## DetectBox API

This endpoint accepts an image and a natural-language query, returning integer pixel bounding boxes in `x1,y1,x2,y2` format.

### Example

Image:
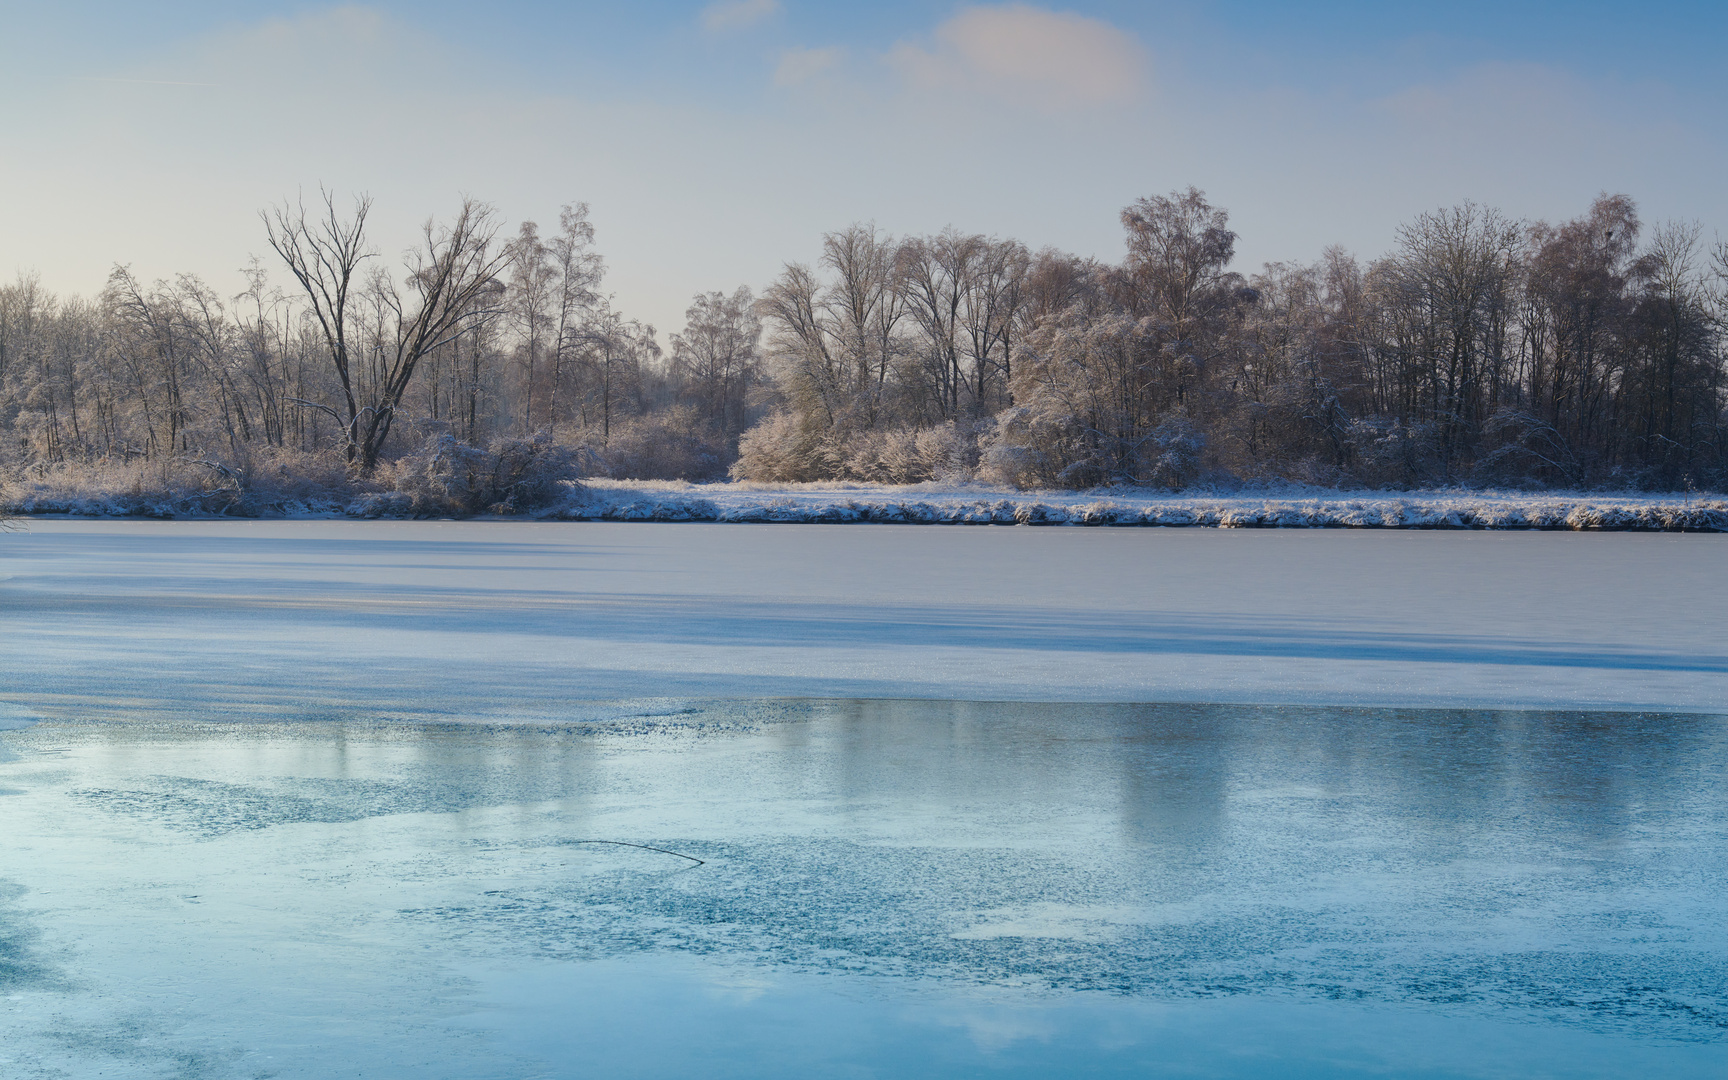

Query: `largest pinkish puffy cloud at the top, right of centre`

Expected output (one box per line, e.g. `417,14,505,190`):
888,3,1147,109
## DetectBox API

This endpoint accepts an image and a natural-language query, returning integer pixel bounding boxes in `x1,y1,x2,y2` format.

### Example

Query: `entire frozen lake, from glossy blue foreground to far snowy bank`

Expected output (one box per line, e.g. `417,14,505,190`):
0,520,1728,1080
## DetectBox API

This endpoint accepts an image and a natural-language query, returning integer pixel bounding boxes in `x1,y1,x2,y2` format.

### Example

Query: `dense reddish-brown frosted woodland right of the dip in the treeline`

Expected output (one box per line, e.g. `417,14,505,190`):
749,188,1728,487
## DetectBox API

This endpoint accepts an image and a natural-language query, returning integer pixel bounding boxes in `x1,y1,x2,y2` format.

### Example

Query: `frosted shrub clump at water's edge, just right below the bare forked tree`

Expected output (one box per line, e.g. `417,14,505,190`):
378,432,579,517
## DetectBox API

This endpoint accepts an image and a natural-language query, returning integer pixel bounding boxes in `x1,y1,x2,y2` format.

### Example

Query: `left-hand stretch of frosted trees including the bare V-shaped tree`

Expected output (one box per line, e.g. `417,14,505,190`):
0,195,760,490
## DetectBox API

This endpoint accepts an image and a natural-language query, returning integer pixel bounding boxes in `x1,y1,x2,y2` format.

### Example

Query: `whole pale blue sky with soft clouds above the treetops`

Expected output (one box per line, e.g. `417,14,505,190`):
0,0,1728,330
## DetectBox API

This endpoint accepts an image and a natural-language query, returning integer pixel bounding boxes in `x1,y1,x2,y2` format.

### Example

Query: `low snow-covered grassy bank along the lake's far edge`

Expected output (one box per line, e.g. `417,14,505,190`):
9,480,1728,532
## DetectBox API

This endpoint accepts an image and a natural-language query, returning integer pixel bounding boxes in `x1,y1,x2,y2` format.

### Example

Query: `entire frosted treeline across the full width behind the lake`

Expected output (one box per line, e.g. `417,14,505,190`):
0,188,1728,498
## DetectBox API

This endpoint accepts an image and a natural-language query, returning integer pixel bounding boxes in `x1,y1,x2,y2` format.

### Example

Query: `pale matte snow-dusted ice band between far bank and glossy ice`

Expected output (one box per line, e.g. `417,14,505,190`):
0,520,1728,721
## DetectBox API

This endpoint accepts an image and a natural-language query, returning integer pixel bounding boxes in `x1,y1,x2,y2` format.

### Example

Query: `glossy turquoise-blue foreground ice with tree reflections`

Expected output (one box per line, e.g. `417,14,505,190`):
0,702,1728,1077
